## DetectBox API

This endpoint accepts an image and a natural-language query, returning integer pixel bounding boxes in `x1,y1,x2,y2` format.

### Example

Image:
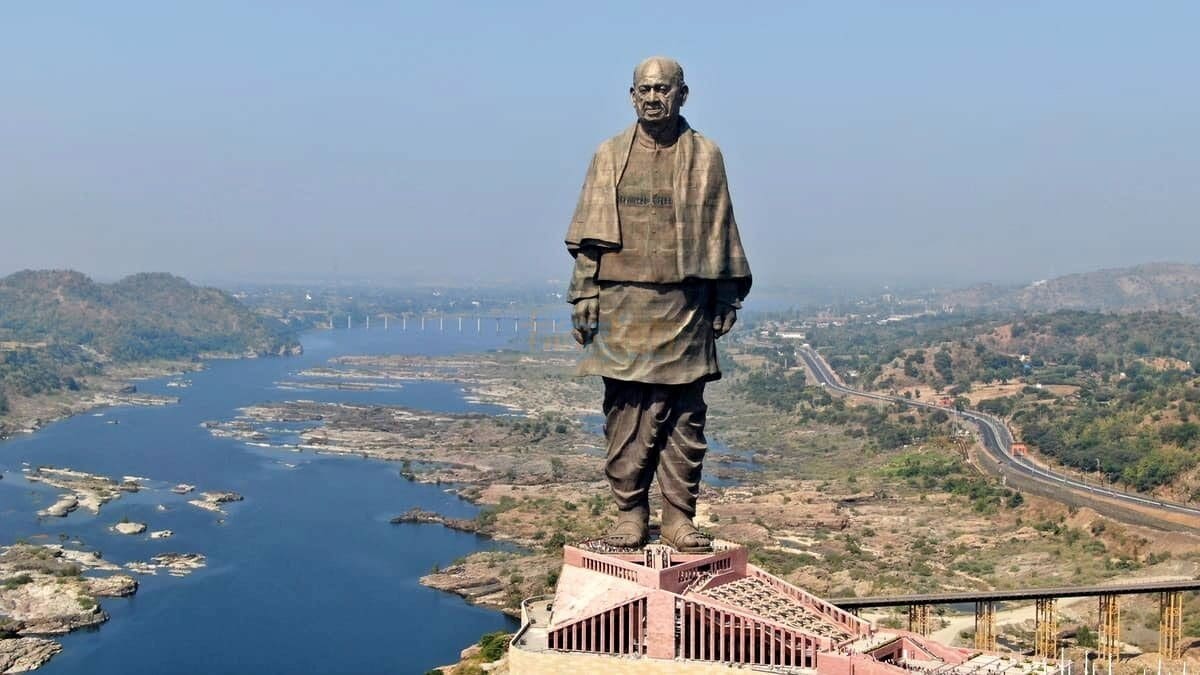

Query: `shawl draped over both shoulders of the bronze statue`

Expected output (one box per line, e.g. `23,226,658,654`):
566,118,751,298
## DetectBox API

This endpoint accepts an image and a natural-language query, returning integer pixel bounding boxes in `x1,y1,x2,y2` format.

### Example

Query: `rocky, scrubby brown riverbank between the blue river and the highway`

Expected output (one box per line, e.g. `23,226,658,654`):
283,345,1196,658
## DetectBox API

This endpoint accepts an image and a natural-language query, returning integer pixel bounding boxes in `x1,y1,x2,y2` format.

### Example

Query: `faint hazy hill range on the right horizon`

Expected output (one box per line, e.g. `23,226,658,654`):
942,263,1200,316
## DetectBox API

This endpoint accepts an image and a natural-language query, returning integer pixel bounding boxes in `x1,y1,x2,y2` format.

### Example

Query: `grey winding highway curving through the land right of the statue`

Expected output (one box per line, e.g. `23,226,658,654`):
796,345,1200,532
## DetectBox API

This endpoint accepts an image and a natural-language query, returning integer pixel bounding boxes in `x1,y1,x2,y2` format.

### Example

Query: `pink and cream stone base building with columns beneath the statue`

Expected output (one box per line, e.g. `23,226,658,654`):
509,542,1058,675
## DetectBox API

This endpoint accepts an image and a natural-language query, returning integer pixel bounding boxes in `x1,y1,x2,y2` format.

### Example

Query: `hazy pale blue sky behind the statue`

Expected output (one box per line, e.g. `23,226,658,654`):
0,0,1200,287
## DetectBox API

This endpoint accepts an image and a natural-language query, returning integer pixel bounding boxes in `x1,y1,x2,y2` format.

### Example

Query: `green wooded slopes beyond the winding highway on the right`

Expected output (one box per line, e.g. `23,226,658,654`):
796,311,1200,487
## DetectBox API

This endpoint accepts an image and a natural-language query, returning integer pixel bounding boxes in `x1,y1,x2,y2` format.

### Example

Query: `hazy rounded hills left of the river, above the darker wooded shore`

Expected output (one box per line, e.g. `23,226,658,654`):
0,270,299,362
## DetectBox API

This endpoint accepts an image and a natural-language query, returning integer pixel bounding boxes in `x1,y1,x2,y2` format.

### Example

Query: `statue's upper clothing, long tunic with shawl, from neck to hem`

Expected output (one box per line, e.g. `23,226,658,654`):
566,123,750,384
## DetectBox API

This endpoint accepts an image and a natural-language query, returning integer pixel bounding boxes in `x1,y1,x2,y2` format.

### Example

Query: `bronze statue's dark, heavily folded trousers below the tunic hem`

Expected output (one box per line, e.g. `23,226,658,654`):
604,377,708,521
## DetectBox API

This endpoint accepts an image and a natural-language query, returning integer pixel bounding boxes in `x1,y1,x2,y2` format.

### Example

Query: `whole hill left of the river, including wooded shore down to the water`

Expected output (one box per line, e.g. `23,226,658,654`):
0,270,299,416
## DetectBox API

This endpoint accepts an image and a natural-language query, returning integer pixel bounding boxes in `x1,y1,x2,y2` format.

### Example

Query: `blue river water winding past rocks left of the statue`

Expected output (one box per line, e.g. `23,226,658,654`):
0,329,540,675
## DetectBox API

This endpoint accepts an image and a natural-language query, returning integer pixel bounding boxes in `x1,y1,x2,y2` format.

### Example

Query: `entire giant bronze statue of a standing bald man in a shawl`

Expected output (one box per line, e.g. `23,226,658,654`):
566,56,751,552
